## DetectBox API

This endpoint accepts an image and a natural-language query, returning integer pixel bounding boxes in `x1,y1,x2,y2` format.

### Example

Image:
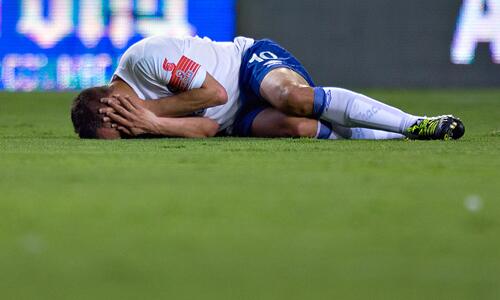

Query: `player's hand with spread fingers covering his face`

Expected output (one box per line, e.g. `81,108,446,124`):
99,95,158,136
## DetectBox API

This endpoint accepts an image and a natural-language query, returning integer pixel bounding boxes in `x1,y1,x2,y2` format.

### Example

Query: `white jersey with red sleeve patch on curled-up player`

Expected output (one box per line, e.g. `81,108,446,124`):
114,36,254,131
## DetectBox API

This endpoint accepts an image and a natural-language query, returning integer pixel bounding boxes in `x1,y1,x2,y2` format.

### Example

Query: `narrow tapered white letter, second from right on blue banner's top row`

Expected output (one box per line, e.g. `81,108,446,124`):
109,0,134,48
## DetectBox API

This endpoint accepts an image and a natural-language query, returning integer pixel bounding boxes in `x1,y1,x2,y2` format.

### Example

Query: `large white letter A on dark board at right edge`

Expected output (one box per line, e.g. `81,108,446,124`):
451,0,500,64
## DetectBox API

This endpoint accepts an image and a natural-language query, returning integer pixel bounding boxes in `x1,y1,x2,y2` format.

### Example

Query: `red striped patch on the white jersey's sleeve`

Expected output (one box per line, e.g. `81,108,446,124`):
167,56,201,92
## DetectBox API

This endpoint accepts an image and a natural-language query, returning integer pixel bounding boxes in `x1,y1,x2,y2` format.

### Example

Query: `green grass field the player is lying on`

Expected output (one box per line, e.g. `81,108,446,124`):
0,90,500,300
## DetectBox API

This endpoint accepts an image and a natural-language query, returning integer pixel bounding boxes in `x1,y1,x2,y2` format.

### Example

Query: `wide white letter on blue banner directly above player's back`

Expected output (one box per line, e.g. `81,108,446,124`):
137,0,195,37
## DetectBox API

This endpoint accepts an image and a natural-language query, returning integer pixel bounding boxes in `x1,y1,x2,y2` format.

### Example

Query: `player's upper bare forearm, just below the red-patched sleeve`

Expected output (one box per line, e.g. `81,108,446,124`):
145,89,227,117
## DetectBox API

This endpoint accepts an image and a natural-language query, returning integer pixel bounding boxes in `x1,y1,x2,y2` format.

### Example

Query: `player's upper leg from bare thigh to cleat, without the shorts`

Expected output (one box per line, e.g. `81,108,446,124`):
260,68,464,139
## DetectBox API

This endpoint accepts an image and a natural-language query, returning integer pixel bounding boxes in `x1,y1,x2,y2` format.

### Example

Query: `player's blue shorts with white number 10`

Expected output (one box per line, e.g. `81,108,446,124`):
232,40,315,137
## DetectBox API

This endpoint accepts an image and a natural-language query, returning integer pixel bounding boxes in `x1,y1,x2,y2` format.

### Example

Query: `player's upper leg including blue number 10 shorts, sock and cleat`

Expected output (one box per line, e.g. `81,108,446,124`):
240,41,464,139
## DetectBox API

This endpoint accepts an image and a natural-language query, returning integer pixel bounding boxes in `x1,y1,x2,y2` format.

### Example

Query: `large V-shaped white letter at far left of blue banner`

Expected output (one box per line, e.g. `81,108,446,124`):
17,0,73,48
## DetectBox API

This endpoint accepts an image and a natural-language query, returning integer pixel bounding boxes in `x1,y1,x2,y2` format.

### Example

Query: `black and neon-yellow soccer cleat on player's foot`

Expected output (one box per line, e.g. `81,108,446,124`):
405,115,465,140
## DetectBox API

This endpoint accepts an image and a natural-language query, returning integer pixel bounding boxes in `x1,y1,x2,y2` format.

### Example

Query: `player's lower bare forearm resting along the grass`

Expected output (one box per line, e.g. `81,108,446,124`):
154,117,219,138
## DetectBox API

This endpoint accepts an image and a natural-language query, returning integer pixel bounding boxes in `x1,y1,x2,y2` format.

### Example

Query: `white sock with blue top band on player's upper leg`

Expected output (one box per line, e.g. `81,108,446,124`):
314,88,420,133
